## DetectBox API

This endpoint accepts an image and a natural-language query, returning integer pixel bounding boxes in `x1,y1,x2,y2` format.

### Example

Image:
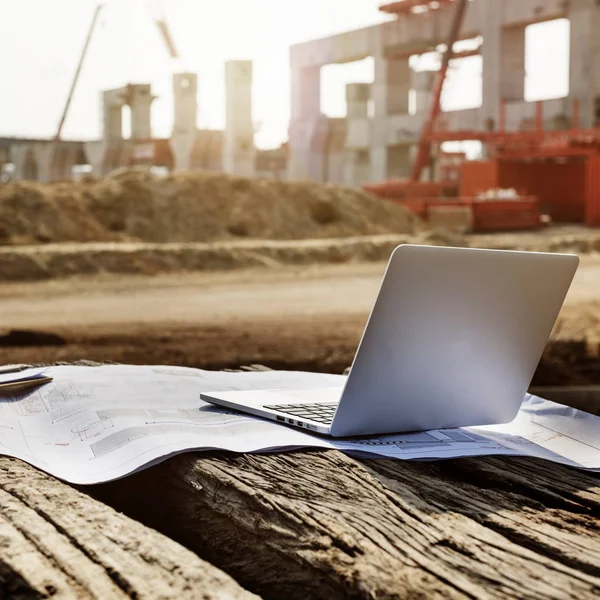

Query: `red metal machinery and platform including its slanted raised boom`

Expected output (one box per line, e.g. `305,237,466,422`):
364,0,600,231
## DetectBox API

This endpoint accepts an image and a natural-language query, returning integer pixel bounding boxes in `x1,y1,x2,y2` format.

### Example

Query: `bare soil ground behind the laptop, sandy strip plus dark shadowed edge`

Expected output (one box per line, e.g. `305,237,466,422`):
0,255,600,385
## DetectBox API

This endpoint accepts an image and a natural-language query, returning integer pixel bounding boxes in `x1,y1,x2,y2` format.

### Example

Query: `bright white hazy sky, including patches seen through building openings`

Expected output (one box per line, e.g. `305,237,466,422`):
0,0,568,148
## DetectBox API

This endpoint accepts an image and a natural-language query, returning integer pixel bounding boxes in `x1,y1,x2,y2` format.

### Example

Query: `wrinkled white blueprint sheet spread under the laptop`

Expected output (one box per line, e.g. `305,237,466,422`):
0,365,600,484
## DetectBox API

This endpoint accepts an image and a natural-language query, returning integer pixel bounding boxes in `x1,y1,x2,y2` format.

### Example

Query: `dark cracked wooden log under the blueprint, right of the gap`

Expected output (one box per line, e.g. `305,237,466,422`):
92,451,600,600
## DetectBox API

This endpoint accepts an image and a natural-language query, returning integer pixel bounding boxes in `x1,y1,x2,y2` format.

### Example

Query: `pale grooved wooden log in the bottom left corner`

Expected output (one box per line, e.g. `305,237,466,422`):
0,457,256,600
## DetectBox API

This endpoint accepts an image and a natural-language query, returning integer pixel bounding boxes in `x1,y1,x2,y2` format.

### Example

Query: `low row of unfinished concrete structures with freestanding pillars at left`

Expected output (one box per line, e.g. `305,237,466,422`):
0,61,264,181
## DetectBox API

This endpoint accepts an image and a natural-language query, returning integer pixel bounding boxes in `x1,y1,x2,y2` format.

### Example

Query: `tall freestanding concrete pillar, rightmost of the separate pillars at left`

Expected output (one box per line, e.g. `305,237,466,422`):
223,60,256,177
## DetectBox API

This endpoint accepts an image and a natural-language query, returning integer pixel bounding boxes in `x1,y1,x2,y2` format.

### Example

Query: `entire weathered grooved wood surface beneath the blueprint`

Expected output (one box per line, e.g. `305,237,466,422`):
0,364,600,600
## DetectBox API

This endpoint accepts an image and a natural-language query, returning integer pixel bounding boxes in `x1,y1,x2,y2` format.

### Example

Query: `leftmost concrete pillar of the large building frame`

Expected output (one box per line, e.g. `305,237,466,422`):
288,64,321,180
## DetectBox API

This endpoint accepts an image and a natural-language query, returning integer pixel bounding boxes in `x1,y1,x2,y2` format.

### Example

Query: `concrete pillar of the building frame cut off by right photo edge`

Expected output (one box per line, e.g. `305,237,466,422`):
569,0,600,127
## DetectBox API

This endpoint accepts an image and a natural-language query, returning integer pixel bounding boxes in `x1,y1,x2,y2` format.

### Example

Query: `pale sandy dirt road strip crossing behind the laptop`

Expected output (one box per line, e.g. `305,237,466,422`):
0,256,600,329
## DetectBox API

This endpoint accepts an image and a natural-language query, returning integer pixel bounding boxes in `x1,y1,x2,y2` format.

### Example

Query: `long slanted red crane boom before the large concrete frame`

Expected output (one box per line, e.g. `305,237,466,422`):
410,0,469,182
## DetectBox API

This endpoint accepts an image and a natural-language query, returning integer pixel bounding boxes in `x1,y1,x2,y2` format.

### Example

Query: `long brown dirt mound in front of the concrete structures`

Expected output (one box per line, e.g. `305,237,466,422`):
0,169,420,245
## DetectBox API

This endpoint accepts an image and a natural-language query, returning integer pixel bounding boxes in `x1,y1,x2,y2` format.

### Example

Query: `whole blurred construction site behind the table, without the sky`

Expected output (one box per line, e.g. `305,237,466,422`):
0,0,600,385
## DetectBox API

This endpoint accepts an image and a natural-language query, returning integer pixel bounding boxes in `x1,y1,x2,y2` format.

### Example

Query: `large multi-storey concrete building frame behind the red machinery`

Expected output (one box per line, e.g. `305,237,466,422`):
289,0,600,185
